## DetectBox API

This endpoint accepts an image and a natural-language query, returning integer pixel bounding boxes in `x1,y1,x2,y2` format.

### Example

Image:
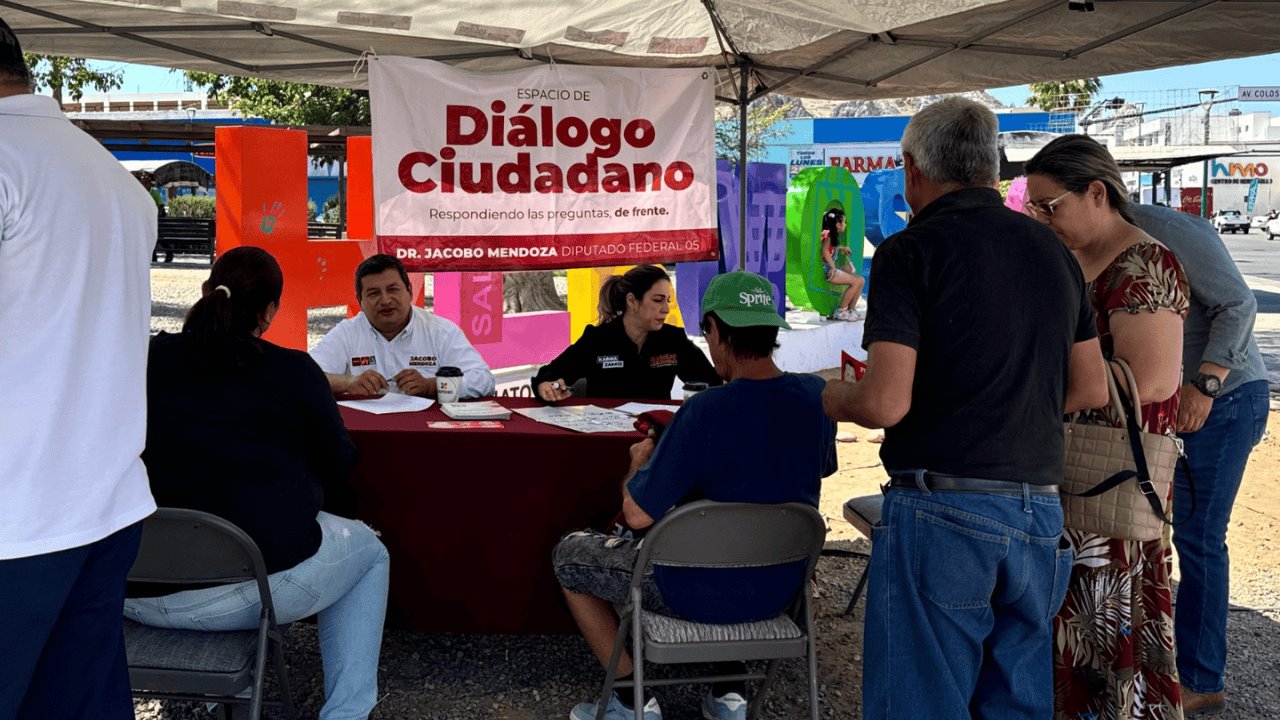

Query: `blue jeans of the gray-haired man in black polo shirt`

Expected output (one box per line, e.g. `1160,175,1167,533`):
863,486,1073,720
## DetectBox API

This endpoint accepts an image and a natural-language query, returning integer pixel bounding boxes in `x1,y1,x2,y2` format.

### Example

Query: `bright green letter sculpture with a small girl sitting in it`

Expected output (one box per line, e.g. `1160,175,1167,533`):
786,167,865,316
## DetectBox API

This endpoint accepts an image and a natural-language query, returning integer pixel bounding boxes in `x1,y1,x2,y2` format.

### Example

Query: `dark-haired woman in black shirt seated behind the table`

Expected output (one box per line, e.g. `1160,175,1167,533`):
532,265,721,402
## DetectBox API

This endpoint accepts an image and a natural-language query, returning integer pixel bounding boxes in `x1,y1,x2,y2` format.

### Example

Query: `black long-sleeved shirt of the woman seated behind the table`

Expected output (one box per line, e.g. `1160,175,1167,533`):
534,319,722,400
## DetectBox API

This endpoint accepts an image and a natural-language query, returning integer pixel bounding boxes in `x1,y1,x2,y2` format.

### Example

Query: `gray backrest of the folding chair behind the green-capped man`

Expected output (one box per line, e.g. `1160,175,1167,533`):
636,500,827,578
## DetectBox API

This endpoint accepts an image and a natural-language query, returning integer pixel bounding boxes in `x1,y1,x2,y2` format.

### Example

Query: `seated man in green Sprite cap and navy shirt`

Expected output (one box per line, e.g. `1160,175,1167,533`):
554,272,836,720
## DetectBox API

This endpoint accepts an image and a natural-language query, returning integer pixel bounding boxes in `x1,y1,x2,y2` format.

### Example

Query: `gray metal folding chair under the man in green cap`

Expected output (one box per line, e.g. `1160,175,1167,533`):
596,501,827,720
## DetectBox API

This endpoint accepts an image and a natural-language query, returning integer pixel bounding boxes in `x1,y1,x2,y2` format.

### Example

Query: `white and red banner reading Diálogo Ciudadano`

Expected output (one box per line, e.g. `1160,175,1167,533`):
369,58,718,270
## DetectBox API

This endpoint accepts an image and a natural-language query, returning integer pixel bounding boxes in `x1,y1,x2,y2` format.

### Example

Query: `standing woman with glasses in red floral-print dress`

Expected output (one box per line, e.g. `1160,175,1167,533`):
1024,135,1189,720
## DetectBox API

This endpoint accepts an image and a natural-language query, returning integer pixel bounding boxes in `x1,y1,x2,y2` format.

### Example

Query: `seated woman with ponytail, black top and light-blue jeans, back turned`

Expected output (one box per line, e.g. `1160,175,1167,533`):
124,247,389,717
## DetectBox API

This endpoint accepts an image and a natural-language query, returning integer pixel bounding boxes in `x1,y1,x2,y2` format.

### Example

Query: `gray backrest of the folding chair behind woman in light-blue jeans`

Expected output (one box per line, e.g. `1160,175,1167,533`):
129,507,270,591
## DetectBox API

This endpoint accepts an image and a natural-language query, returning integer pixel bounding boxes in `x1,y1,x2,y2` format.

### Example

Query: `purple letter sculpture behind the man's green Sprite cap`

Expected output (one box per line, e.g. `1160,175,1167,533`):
676,160,787,336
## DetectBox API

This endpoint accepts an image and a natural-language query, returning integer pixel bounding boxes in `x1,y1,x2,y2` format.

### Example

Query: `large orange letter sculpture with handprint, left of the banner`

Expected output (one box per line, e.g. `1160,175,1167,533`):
214,127,374,350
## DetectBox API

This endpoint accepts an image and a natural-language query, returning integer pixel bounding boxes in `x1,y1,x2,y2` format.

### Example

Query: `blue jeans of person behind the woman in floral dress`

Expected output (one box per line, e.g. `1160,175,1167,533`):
1174,380,1268,693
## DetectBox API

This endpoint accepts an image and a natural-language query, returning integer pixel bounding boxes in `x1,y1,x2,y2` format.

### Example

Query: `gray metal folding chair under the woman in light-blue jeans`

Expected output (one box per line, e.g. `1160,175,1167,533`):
124,507,294,720
